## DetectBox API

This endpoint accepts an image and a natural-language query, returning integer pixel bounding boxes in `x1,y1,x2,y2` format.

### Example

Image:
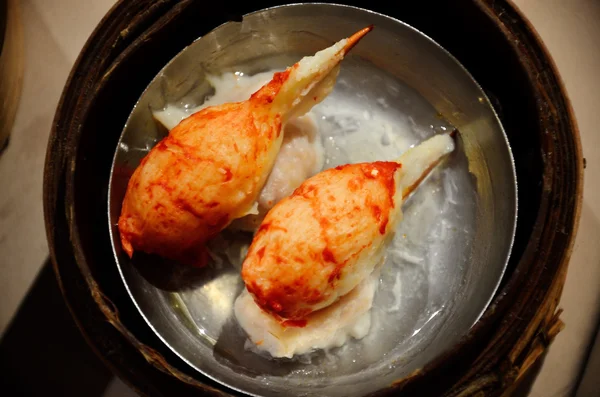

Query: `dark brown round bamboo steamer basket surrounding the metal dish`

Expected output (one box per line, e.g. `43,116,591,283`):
44,0,583,396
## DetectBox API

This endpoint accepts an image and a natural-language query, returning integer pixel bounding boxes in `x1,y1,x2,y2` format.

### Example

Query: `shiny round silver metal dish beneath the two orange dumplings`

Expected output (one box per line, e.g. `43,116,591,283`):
108,4,516,396
